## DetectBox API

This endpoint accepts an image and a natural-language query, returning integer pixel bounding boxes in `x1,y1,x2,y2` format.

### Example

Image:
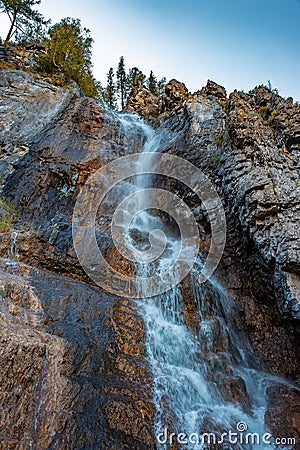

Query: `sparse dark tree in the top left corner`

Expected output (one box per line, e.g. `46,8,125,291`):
0,0,50,45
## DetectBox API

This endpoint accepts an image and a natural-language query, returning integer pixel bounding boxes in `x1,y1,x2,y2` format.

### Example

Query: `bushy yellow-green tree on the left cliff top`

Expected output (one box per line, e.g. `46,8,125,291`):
38,17,101,98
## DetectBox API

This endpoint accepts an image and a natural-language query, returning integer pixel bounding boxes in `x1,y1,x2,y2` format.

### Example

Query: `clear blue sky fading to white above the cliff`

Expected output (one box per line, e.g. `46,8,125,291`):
0,0,300,101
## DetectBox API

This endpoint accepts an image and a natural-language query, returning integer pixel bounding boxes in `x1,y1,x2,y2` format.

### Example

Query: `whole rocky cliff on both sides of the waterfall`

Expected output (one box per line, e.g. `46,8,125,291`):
0,64,300,449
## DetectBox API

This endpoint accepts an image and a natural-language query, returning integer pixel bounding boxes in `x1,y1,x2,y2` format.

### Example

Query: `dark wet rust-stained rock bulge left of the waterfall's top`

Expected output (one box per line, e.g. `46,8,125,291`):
4,98,142,226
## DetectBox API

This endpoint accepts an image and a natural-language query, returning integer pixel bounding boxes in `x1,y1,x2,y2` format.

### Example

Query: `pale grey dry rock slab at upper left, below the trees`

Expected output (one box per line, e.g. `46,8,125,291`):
0,68,80,184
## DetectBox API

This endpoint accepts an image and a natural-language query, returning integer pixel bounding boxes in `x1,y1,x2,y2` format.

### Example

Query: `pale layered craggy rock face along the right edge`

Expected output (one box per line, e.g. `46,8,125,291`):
223,88,300,319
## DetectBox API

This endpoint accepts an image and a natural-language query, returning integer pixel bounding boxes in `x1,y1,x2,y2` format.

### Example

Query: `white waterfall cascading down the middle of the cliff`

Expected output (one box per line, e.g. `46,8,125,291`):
109,110,296,450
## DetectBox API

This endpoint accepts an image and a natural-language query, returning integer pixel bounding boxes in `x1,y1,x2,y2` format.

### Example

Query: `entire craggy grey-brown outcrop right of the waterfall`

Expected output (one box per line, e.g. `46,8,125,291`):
144,82,300,377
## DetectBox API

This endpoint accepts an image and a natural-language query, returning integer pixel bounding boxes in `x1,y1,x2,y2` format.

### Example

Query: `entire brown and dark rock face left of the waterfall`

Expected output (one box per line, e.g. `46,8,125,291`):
0,70,155,450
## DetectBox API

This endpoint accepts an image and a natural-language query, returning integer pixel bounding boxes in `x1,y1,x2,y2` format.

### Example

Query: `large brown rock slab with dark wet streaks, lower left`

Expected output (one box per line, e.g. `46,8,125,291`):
0,260,154,450
